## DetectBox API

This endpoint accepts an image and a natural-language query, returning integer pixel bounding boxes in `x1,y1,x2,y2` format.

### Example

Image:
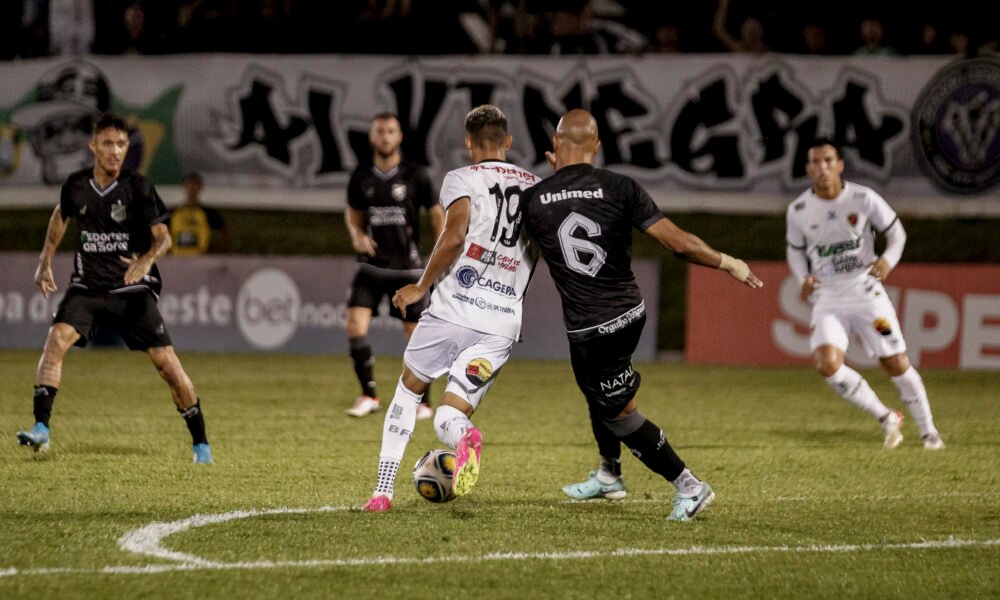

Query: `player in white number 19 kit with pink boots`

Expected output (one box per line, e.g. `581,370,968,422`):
363,104,538,512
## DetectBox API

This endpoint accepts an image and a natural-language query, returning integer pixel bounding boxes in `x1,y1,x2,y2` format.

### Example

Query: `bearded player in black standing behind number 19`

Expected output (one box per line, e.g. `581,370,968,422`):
344,113,444,419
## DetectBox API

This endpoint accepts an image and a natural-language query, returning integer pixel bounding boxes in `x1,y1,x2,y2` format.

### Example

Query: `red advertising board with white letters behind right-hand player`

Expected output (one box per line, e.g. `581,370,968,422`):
685,262,1000,369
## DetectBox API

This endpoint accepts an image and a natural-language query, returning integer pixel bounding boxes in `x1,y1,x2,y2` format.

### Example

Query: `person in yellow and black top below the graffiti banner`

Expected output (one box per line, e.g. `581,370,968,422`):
170,173,229,256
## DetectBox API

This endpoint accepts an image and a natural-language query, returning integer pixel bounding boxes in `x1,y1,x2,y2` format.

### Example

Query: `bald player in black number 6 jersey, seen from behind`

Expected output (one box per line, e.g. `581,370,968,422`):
521,109,763,521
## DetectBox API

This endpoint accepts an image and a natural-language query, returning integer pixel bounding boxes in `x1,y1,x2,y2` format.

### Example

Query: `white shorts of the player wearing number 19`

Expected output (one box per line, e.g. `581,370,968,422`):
403,313,514,409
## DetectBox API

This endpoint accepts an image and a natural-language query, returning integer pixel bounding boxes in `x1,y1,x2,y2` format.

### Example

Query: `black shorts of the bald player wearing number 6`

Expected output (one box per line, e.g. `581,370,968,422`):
569,315,646,419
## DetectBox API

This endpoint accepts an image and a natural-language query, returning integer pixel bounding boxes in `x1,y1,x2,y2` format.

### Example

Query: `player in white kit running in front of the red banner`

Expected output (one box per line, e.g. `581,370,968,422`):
786,139,944,450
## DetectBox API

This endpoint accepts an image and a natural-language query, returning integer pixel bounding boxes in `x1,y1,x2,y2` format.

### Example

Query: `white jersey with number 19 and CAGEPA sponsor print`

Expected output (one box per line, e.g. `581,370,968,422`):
427,160,539,340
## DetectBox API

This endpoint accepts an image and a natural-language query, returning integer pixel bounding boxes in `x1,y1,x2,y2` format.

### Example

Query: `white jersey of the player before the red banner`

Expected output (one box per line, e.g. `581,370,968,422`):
785,181,897,300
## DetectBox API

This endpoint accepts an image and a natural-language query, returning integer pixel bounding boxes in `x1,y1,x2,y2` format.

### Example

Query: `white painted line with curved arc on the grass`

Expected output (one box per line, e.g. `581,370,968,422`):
0,506,1000,577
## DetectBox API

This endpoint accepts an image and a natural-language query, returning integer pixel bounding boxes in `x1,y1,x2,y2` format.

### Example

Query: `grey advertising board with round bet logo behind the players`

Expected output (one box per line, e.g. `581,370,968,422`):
0,252,660,361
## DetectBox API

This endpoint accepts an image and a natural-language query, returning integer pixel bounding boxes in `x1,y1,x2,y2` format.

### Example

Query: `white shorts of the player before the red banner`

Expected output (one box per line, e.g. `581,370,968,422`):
809,292,906,358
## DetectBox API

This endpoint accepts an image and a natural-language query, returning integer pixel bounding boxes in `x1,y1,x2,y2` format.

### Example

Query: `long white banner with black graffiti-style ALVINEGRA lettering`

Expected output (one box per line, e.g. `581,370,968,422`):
0,54,1000,212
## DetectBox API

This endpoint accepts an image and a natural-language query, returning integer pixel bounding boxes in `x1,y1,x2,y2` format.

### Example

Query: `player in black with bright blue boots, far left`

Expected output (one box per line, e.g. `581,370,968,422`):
17,114,212,463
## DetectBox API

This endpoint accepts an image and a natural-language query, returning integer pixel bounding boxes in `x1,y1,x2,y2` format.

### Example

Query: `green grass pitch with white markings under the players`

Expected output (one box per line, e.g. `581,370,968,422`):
0,350,1000,599
